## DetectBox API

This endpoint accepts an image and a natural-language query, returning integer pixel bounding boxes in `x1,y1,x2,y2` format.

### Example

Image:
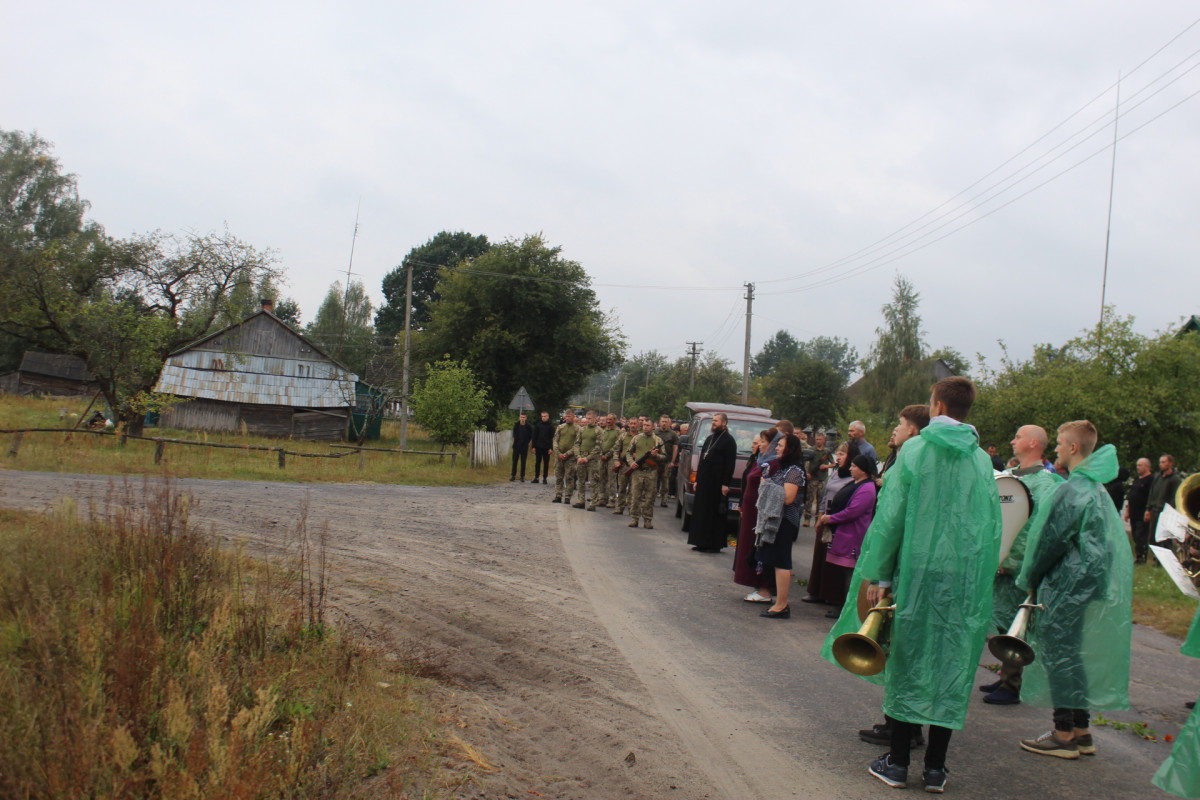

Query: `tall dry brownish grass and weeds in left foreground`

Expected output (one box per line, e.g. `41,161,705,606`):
0,487,468,798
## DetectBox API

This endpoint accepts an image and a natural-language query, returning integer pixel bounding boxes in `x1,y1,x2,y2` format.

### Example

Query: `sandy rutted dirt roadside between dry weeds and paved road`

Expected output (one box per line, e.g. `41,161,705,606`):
0,470,721,799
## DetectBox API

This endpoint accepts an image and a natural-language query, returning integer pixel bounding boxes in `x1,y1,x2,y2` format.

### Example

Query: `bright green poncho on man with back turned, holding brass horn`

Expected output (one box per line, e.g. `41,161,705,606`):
821,419,1001,729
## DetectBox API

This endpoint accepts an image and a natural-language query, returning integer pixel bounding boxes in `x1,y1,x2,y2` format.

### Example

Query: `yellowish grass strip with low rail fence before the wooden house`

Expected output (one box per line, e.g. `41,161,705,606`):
0,396,508,486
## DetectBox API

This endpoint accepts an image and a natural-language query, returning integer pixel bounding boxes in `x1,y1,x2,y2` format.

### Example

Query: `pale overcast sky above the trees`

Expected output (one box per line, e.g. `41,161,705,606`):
0,0,1200,381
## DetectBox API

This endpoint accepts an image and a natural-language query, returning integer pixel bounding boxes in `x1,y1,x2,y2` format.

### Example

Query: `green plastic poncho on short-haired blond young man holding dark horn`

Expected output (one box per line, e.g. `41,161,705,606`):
1016,445,1133,711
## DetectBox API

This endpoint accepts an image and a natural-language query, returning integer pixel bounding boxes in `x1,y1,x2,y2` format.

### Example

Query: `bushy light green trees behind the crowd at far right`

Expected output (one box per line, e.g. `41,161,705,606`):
970,313,1200,471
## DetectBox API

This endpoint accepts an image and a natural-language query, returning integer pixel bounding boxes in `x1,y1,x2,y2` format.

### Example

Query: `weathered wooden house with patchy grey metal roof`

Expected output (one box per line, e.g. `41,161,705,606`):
155,305,358,441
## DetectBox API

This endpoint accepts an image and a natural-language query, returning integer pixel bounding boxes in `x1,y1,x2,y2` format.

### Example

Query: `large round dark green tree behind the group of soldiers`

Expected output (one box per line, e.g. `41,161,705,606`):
414,235,624,425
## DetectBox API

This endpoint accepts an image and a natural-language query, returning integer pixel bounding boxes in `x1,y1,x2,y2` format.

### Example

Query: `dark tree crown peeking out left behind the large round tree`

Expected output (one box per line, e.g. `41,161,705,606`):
376,230,491,342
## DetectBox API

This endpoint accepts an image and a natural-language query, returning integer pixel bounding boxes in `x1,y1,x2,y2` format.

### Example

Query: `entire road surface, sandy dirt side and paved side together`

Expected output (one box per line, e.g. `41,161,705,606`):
0,471,1200,800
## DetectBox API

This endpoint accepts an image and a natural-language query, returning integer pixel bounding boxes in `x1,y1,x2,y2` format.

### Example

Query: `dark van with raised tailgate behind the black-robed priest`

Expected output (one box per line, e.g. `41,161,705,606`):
676,403,779,530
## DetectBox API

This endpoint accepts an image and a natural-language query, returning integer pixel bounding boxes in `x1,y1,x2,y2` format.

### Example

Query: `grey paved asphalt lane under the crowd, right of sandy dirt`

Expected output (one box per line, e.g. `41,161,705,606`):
559,496,1200,800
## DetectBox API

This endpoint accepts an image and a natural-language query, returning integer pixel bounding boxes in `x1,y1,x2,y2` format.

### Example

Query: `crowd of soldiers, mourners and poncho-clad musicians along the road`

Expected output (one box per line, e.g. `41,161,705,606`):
514,378,1200,796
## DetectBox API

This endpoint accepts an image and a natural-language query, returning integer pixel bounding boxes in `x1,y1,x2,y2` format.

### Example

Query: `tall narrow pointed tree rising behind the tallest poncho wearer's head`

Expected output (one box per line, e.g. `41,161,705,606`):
863,275,932,411
